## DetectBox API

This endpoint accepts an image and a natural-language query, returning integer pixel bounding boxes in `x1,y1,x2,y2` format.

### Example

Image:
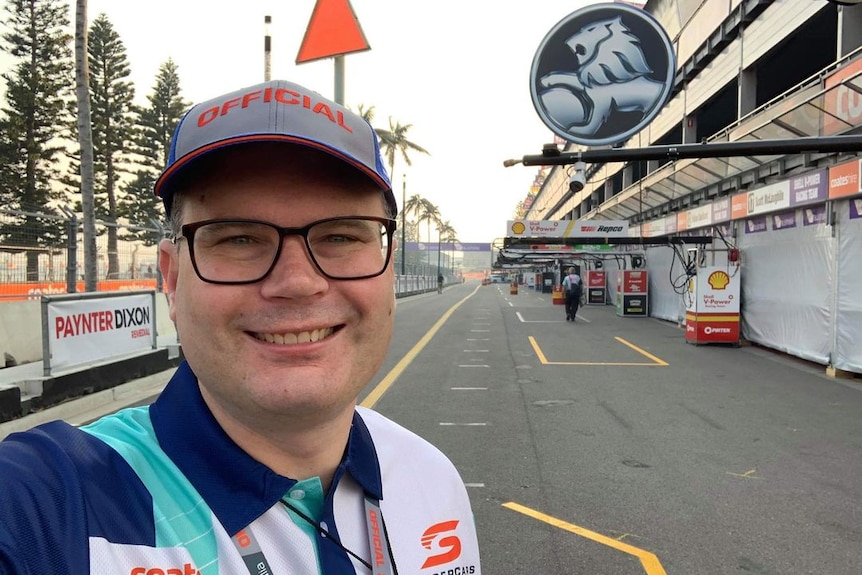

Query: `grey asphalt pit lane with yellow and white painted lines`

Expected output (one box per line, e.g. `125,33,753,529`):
27,282,862,575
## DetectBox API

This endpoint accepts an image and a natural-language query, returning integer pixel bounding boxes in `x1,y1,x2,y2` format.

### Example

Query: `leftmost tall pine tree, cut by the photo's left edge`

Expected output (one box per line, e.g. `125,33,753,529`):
0,0,74,281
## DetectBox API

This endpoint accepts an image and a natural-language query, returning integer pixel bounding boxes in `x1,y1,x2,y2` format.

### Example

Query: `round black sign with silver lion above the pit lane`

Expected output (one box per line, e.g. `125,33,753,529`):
530,3,676,146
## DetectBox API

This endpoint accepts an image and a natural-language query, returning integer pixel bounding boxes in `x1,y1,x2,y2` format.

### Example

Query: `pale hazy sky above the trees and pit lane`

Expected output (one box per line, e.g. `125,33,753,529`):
6,0,604,242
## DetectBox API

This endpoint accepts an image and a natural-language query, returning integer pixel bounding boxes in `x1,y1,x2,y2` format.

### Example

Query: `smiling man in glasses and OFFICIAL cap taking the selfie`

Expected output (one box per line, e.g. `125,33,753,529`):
0,82,480,575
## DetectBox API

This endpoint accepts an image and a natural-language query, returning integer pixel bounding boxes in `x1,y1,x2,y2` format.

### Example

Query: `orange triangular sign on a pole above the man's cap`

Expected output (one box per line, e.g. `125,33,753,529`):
296,0,371,64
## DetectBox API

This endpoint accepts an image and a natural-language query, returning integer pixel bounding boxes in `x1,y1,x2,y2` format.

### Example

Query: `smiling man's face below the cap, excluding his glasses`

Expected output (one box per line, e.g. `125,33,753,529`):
161,146,395,427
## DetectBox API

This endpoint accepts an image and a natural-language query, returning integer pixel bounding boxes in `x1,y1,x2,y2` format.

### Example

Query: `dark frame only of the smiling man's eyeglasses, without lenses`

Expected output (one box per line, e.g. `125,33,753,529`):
171,216,397,285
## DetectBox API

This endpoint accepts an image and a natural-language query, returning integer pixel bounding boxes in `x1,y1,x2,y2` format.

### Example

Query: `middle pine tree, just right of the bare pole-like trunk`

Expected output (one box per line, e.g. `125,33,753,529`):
87,14,135,279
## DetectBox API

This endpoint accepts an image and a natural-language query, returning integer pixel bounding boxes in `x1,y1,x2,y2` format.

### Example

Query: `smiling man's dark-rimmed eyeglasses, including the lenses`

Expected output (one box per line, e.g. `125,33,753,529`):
173,216,396,284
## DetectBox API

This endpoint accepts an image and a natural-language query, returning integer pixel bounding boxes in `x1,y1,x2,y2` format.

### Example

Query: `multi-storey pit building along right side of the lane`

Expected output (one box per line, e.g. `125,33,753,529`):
524,0,862,373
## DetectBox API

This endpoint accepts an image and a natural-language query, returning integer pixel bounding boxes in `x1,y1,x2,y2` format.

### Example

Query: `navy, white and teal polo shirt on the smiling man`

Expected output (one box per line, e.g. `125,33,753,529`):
0,363,480,575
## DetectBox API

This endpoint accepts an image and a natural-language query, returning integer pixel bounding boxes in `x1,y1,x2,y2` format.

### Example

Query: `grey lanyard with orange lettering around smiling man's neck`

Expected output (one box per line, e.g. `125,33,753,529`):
231,495,398,575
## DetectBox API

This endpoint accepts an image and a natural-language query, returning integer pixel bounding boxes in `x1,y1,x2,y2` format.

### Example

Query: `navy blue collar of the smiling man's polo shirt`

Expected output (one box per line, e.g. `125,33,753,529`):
150,361,383,534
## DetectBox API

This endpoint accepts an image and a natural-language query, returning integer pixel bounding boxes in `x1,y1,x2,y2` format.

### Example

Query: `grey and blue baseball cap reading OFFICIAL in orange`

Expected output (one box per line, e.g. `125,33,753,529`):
154,80,398,215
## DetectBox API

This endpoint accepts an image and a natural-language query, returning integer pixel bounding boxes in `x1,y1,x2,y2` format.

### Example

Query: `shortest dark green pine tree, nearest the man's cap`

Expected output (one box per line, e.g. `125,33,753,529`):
120,59,190,245
